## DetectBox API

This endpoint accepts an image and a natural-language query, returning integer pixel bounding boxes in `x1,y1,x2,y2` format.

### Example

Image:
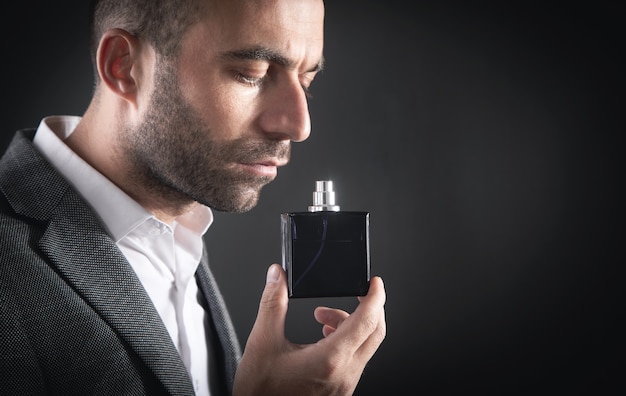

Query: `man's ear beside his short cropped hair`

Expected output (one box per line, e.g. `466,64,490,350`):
96,29,147,103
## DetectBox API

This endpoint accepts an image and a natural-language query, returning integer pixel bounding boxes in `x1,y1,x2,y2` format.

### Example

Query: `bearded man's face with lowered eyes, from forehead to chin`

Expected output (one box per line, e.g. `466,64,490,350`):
118,0,324,212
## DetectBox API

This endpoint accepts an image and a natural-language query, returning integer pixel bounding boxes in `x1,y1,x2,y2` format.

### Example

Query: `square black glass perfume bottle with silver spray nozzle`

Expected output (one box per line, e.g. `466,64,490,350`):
281,180,370,298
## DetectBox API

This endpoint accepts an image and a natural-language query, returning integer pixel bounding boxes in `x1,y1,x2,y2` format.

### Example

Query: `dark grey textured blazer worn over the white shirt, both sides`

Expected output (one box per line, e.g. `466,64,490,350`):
0,130,241,395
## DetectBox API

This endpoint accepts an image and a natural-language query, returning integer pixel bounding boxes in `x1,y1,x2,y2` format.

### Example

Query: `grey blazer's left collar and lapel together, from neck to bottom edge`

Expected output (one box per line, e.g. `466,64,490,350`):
0,134,193,395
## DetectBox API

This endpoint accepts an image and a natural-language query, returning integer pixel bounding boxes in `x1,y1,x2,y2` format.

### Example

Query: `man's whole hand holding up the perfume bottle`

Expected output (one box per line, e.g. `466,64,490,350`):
233,264,386,396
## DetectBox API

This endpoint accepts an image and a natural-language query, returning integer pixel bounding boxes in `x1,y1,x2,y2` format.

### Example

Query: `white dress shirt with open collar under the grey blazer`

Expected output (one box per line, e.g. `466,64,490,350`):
34,116,213,395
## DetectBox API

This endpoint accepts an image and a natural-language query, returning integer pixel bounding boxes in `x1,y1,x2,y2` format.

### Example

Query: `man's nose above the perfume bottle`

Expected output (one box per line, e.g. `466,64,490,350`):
260,78,311,142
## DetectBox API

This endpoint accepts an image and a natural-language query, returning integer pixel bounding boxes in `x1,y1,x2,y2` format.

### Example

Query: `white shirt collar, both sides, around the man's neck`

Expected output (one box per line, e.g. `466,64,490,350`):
33,116,213,242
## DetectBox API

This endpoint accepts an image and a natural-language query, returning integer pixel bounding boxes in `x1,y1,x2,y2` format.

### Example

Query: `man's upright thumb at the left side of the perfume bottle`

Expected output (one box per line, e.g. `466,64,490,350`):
250,264,289,342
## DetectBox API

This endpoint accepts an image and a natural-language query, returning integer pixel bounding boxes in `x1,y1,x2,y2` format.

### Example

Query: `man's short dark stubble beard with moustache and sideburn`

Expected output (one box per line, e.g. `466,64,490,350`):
119,63,290,212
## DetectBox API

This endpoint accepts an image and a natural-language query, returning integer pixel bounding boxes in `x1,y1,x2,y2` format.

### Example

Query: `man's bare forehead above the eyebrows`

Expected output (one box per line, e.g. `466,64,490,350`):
189,0,324,66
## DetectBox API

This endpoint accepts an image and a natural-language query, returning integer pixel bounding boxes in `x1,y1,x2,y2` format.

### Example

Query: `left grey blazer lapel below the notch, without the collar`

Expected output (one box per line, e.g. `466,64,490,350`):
40,198,193,394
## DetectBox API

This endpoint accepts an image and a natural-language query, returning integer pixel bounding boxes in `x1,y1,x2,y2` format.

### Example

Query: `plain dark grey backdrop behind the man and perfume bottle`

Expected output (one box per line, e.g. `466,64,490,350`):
0,0,625,395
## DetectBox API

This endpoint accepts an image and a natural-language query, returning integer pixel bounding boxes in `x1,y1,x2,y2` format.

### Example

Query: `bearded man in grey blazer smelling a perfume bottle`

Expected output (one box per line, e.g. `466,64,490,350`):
0,0,386,395
